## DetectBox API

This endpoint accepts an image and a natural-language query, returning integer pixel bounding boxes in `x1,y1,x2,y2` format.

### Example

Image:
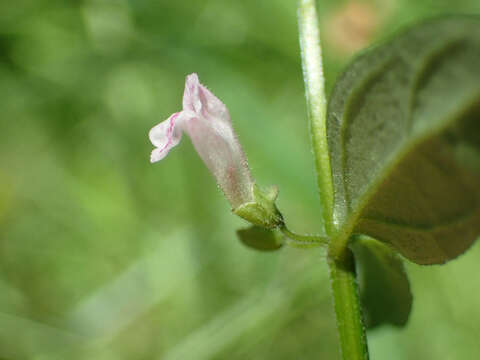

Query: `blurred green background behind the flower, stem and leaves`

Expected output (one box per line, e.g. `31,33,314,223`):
0,0,480,360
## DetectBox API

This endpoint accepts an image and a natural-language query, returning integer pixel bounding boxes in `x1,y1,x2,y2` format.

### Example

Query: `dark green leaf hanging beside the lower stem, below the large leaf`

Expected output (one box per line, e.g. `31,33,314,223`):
352,236,412,328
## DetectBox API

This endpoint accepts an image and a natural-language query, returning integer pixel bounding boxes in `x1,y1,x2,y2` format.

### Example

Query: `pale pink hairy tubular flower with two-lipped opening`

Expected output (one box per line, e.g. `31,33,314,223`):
149,74,255,209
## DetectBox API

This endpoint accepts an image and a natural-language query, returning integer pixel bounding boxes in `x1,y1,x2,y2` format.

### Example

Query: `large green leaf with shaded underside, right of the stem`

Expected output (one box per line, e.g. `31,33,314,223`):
327,17,480,264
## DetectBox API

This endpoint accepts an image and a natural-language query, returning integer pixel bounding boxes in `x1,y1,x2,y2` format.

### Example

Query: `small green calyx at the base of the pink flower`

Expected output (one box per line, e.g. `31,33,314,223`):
233,184,283,229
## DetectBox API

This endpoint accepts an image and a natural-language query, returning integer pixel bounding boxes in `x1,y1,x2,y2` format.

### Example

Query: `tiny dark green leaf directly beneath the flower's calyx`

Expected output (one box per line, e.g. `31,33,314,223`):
237,226,284,251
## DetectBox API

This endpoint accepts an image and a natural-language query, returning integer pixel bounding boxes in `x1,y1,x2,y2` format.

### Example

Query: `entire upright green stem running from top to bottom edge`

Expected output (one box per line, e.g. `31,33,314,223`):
298,0,368,360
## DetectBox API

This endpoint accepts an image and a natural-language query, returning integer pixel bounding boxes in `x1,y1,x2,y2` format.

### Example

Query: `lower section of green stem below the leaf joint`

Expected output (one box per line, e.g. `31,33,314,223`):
328,249,368,360
